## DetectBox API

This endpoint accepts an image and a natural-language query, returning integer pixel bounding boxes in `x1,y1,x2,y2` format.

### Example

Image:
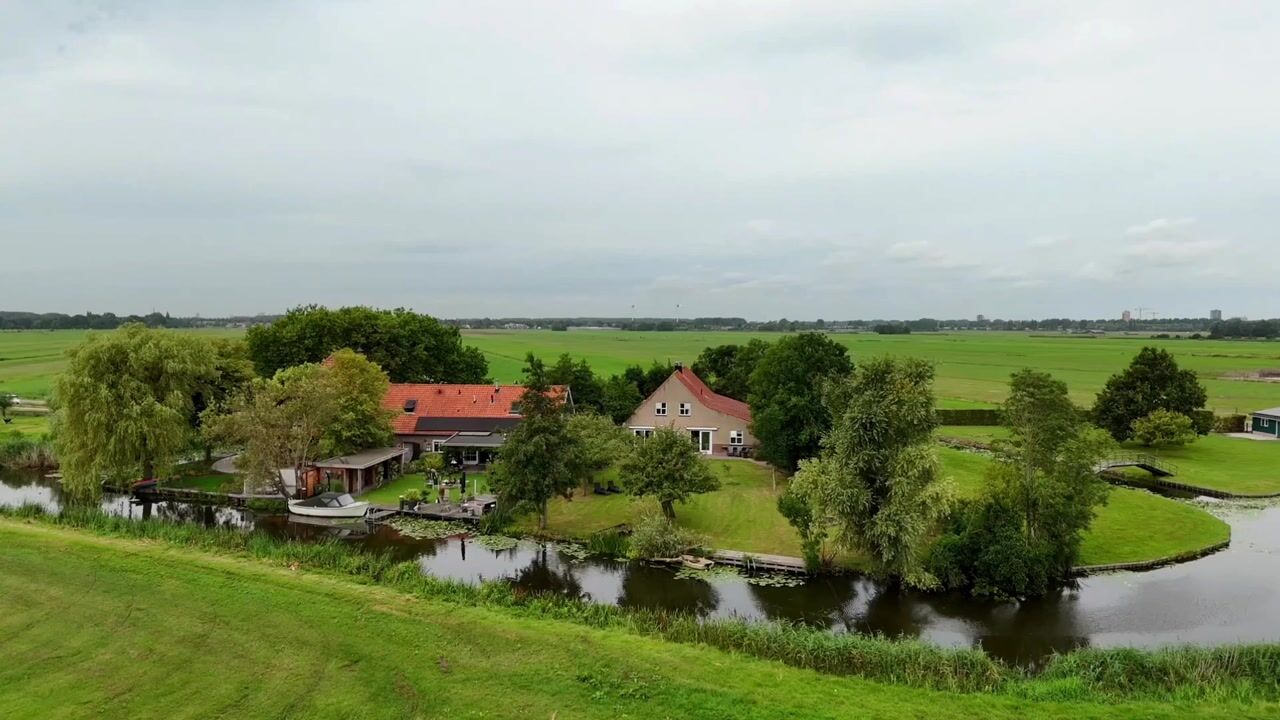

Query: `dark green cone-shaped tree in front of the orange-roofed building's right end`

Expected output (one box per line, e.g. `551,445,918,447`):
490,363,584,529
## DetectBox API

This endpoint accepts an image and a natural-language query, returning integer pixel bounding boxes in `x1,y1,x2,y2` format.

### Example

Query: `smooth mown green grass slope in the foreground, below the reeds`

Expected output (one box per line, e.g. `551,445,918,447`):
0,520,1276,720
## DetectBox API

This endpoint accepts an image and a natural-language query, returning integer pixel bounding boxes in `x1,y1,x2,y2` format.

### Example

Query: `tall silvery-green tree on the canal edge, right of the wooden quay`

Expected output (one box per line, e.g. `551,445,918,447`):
790,357,952,585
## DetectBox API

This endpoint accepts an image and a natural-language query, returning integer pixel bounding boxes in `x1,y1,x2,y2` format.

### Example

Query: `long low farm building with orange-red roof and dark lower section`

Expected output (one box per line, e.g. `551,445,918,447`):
383,383,572,465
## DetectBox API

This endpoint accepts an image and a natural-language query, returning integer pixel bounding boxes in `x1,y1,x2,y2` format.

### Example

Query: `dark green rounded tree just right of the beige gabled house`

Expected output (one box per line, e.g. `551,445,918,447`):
749,333,854,470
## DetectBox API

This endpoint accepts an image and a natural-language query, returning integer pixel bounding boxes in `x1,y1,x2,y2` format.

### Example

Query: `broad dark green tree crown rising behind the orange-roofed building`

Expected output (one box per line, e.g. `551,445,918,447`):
246,305,488,383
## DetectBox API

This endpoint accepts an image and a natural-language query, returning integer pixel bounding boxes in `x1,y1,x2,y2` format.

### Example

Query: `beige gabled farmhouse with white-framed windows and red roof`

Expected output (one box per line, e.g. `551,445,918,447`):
627,364,756,456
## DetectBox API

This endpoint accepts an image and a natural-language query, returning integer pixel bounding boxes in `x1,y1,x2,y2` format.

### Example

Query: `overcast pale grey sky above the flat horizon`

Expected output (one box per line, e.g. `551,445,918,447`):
0,0,1280,319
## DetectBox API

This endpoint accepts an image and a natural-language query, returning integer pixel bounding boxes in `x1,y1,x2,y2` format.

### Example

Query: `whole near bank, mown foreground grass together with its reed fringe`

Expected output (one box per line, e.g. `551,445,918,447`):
0,519,1280,719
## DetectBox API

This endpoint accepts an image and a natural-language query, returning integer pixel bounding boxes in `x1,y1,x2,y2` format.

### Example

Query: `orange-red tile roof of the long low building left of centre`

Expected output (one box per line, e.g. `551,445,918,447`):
383,383,567,434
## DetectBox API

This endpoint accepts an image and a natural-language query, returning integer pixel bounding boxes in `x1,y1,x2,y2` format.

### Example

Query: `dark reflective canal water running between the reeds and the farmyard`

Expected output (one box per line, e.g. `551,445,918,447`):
0,473,1280,665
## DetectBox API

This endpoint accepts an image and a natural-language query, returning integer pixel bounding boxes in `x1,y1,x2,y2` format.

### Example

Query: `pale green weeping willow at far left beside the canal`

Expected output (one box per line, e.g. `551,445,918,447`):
52,324,215,498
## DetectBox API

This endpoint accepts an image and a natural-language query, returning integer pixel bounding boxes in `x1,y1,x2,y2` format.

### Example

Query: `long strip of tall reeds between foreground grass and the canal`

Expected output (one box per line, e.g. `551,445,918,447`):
10,506,1280,702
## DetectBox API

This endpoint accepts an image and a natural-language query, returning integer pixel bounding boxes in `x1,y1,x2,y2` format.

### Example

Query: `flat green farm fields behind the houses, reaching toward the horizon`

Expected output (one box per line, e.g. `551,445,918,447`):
0,329,1280,413
